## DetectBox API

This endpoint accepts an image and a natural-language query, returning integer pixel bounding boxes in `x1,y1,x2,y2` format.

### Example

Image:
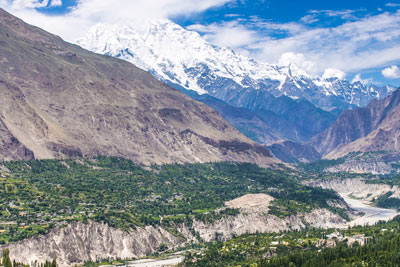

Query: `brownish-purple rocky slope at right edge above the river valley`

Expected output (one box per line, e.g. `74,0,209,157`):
310,90,400,158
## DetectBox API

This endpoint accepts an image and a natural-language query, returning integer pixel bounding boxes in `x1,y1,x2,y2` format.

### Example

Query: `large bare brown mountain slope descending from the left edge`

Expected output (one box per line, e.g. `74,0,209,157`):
0,7,276,164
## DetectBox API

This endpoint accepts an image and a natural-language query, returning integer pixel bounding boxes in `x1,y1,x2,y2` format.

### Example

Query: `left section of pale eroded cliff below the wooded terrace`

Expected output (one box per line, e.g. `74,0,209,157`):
3,222,193,267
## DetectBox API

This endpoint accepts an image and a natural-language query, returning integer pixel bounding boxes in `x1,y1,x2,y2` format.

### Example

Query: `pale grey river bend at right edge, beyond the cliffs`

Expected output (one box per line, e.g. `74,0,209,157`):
340,194,399,226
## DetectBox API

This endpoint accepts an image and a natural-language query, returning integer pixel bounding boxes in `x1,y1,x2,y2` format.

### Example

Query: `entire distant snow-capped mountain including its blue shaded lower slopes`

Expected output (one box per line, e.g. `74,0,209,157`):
76,20,394,151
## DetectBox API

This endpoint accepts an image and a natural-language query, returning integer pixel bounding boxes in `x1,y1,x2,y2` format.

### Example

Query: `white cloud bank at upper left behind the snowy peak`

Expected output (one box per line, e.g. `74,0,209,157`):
0,0,234,41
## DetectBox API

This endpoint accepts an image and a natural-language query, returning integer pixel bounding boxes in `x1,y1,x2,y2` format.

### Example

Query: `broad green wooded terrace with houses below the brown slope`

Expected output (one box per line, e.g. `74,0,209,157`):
0,157,345,244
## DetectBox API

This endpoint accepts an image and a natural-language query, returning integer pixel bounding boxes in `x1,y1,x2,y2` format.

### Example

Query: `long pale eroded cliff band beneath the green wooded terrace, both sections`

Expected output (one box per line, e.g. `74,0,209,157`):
0,209,347,267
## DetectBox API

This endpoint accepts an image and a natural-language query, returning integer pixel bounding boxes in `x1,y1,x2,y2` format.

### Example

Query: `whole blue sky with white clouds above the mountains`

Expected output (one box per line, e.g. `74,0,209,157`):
0,0,400,86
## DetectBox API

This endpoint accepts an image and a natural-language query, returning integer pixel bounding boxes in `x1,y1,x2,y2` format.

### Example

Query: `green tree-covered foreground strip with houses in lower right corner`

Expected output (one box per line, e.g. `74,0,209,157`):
183,216,400,267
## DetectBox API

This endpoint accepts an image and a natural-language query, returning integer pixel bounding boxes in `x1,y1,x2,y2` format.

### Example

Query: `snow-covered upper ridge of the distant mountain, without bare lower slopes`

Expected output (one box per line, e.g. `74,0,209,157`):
76,20,394,109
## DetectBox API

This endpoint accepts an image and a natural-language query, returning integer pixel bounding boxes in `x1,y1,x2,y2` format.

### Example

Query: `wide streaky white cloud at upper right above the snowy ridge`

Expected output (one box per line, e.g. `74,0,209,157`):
183,10,400,74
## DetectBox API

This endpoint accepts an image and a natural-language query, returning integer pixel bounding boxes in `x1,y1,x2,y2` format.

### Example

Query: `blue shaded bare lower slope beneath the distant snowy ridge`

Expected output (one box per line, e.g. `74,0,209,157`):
183,90,336,145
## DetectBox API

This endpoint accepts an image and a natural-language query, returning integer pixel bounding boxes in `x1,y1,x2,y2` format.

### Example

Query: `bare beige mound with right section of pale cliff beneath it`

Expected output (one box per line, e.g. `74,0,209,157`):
193,194,346,241
